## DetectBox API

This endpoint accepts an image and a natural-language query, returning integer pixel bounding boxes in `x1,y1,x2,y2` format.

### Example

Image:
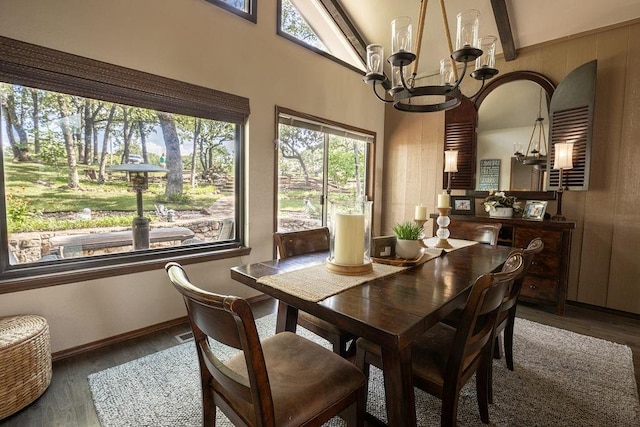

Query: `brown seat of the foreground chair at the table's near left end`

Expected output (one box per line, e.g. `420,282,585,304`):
226,332,366,426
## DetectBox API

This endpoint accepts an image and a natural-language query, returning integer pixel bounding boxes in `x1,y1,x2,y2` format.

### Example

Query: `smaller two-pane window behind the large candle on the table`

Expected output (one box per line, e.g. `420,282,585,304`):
276,108,375,232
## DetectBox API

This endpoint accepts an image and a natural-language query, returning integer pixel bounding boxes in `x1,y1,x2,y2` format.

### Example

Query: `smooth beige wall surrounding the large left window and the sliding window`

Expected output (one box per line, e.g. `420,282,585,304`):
0,0,384,352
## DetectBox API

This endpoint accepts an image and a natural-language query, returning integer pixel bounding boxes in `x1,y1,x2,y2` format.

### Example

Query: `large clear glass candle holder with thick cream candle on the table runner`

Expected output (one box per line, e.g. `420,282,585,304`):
326,202,373,275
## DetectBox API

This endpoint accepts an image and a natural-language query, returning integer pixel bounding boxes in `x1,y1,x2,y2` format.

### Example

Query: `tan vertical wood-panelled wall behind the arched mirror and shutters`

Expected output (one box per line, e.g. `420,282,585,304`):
382,20,640,313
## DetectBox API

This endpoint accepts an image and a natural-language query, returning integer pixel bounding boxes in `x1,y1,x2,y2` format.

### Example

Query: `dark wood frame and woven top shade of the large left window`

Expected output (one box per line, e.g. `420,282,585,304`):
0,36,251,294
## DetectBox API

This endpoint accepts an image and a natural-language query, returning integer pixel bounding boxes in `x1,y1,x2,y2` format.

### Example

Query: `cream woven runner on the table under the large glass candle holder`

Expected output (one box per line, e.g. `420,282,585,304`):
258,263,407,302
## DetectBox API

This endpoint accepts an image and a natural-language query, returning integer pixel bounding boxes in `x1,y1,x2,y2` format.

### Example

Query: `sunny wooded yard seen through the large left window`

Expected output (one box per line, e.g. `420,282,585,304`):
0,83,240,265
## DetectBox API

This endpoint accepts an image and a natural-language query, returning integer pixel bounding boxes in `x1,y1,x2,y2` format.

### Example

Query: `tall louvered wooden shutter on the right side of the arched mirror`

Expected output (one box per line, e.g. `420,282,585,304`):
547,60,597,191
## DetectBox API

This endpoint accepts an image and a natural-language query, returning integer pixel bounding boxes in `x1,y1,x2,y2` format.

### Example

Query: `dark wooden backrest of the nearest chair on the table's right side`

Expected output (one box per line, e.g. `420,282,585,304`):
445,249,524,384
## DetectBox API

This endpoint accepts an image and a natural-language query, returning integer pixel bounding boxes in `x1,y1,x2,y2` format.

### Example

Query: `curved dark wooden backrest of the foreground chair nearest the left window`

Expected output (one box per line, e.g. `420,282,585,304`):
165,262,275,425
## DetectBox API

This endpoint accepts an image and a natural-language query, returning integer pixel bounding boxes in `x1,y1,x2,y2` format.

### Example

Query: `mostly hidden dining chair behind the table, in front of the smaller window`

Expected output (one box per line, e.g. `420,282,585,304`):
273,227,357,357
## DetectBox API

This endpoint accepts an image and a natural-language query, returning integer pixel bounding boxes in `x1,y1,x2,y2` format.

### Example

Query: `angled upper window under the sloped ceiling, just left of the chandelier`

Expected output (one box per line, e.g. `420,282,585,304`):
278,0,366,73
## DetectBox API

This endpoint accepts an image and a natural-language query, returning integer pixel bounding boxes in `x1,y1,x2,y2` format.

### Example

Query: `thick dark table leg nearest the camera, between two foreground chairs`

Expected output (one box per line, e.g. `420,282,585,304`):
382,346,416,427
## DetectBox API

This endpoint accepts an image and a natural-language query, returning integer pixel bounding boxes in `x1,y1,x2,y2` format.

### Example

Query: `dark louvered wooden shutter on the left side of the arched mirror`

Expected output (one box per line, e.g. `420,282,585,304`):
442,98,478,190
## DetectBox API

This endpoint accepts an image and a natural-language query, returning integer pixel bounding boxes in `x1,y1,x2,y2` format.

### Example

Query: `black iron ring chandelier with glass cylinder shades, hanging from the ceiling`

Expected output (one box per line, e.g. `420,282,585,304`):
363,0,498,113
